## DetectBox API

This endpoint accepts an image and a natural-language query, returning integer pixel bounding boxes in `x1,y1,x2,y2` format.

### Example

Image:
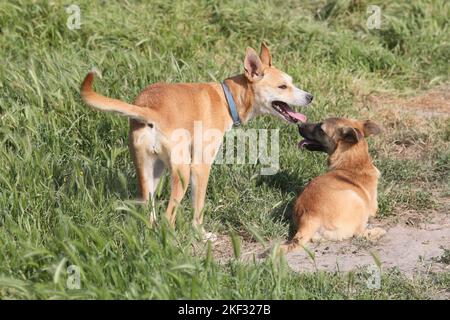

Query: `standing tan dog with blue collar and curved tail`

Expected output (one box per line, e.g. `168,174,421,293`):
81,44,313,231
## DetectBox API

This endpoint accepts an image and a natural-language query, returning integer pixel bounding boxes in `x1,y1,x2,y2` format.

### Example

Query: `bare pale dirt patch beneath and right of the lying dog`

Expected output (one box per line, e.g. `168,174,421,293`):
286,214,450,276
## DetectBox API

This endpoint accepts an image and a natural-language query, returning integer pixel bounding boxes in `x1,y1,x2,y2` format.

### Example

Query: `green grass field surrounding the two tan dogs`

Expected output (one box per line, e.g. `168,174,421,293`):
0,0,450,299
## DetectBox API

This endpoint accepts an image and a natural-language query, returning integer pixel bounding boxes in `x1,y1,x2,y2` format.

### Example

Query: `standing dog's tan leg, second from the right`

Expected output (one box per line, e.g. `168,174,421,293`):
166,164,190,227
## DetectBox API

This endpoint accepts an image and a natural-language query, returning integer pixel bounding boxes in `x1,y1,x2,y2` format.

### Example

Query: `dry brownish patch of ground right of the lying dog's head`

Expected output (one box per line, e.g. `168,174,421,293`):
357,85,450,160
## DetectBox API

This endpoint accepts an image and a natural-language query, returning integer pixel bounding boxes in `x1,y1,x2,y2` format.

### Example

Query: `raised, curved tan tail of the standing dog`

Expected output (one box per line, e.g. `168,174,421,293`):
80,68,157,123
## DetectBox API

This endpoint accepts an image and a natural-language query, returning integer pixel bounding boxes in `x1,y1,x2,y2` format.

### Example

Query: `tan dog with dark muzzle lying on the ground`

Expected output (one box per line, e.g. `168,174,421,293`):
281,118,386,252
